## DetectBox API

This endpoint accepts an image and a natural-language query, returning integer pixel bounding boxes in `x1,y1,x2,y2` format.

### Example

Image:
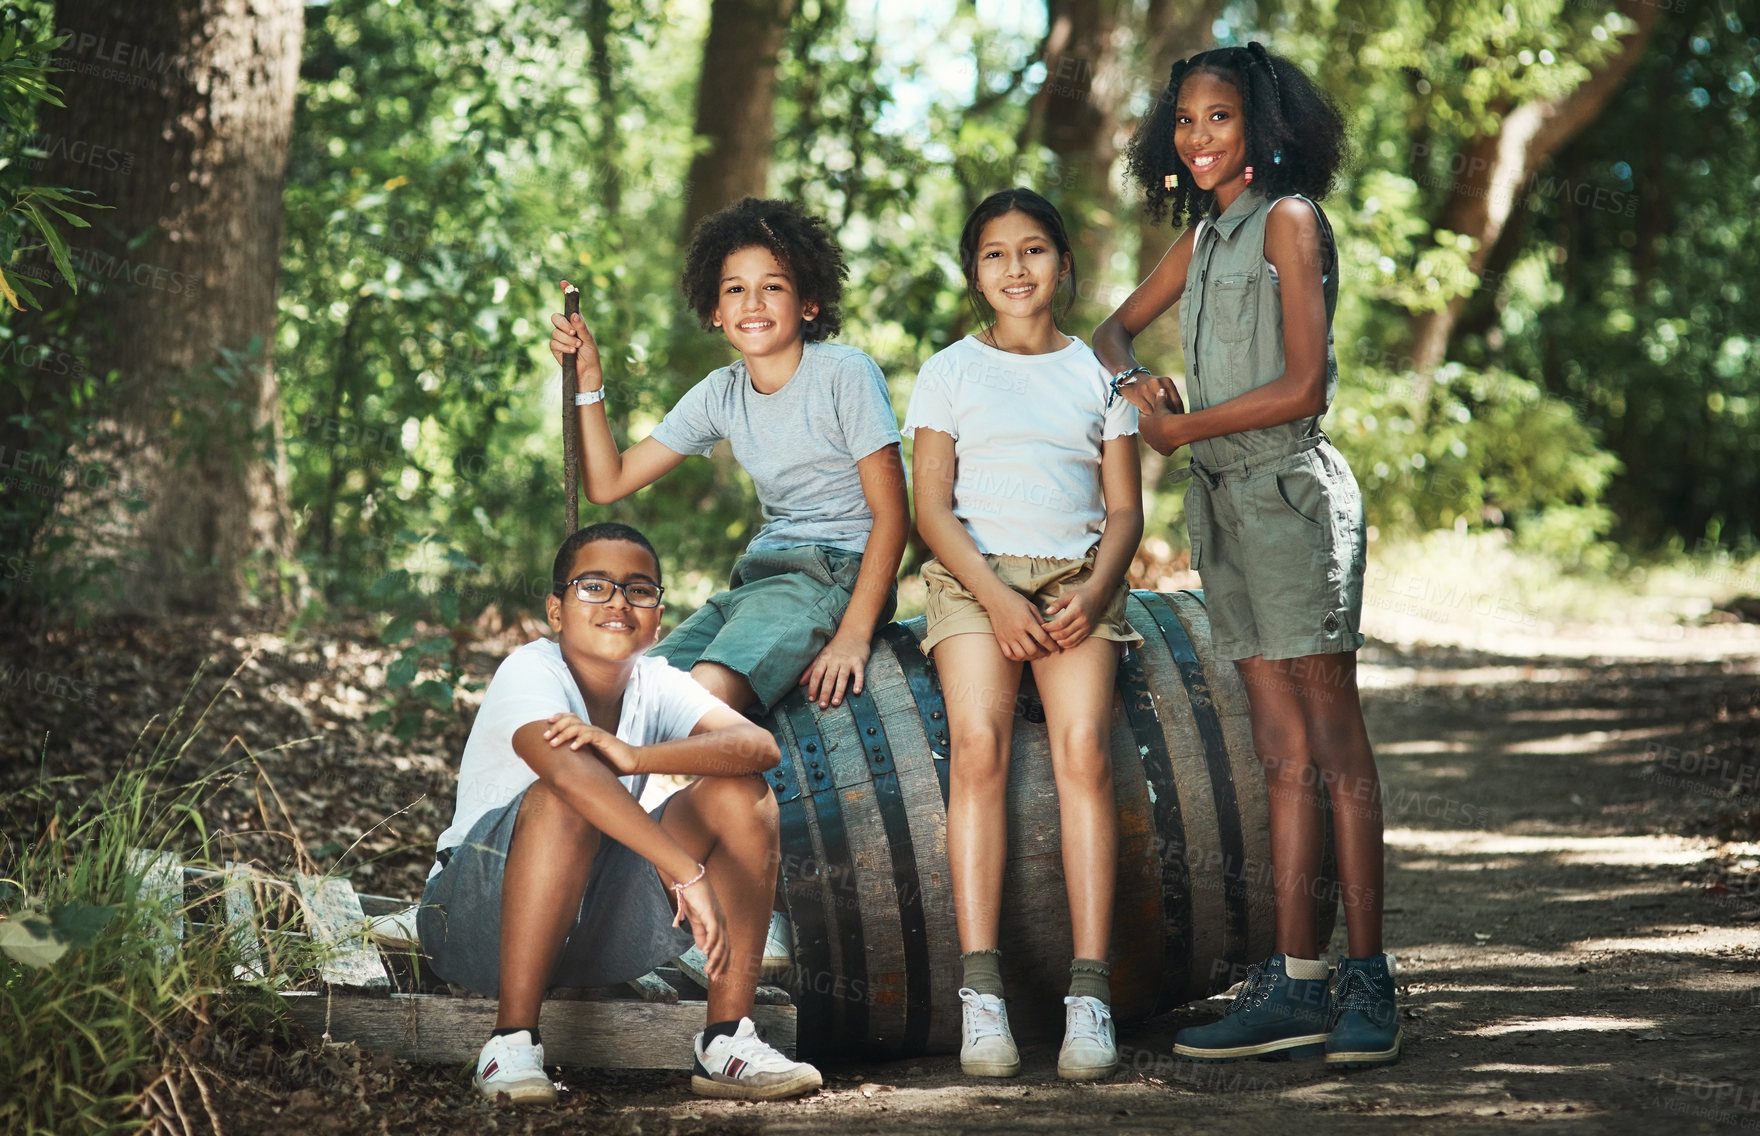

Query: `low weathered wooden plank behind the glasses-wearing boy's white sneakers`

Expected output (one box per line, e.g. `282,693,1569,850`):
282,992,794,1069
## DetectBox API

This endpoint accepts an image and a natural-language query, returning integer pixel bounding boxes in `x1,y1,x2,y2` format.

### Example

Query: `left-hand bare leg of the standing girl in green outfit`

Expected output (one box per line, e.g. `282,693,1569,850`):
1236,655,1320,958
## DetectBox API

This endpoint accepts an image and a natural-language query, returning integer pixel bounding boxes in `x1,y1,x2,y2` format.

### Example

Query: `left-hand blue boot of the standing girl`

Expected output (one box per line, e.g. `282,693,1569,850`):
1174,955,1327,1062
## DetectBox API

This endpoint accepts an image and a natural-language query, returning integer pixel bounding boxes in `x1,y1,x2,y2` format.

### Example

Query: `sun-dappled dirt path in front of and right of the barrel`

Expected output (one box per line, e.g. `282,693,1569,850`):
538,648,1760,1136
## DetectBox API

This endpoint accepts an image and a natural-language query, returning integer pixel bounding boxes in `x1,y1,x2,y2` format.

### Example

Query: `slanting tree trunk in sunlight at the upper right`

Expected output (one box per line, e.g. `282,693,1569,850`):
1412,0,1658,389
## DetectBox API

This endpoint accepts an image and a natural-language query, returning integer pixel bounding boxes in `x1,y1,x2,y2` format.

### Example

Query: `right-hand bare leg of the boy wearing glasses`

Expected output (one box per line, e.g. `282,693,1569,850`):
660,771,780,1022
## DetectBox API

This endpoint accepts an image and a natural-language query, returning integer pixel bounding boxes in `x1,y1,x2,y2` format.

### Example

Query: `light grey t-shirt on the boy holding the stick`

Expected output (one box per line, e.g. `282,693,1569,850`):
653,343,899,553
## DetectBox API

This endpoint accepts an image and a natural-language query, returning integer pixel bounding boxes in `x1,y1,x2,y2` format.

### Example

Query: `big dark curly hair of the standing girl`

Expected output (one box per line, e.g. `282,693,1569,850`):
1125,41,1346,229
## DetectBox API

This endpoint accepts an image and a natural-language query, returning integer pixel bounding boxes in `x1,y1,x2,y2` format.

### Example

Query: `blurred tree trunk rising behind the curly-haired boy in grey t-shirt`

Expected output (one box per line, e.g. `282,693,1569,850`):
685,0,794,240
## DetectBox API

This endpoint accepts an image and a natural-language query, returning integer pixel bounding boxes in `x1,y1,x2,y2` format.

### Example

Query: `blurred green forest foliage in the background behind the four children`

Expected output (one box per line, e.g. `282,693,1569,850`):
276,0,1760,630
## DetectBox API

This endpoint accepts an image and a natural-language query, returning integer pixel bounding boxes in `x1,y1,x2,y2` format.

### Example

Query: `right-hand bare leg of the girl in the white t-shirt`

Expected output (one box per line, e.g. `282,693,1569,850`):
1027,638,1119,960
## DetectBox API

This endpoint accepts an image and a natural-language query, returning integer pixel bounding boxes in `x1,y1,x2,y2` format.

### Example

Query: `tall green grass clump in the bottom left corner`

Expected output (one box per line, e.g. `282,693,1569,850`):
0,675,325,1136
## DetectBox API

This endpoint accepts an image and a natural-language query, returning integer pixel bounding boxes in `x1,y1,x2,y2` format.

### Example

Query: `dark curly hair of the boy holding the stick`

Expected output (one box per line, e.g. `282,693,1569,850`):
679,197,850,343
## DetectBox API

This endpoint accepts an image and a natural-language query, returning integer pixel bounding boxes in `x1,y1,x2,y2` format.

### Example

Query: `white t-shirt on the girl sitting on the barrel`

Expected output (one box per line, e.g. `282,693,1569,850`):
905,335,1137,560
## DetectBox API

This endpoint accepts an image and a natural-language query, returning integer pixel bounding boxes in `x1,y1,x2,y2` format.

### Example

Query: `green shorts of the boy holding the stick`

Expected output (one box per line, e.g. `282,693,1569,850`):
649,544,898,713
